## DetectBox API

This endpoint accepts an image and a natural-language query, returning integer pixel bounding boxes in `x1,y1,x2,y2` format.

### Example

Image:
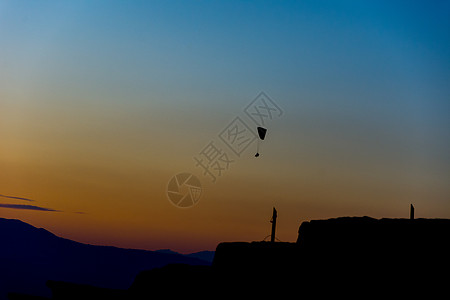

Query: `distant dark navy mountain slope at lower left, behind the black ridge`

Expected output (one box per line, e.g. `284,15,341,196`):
0,218,210,300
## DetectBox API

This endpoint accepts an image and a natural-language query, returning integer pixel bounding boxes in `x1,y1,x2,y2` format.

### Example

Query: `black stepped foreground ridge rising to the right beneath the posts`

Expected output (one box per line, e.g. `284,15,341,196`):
10,217,450,299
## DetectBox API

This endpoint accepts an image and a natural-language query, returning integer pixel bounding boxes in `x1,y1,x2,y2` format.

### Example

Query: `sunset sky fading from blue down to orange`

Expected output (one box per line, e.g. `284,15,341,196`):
0,1,450,252
